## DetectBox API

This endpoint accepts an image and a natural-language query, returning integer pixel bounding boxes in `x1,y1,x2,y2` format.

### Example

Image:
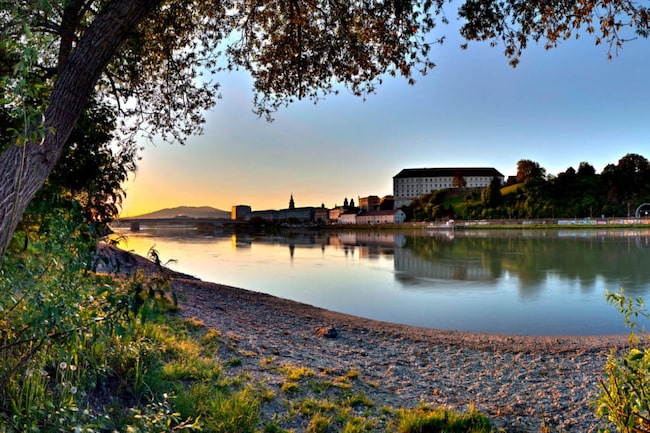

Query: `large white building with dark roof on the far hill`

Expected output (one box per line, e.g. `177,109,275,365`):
393,167,504,209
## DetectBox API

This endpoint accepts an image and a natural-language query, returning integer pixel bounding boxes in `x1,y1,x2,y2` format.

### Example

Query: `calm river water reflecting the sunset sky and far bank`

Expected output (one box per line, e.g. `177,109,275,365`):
109,227,650,335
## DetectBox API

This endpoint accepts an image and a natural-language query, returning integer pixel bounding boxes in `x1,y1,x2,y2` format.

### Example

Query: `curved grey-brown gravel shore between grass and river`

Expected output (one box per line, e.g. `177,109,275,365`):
173,278,627,432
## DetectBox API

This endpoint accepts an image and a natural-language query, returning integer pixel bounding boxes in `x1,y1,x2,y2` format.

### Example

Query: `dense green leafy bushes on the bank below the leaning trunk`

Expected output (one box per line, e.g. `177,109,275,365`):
0,209,180,432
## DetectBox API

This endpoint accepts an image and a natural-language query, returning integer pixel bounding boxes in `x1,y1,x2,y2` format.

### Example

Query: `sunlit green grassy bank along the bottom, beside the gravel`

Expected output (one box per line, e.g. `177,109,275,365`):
0,276,490,433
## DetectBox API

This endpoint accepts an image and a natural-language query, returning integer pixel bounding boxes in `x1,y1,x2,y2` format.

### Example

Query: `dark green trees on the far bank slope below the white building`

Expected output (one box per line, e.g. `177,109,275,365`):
405,153,650,221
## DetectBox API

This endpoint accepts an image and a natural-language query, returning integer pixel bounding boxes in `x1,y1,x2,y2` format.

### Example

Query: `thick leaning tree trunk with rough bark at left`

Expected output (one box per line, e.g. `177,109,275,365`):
0,0,162,265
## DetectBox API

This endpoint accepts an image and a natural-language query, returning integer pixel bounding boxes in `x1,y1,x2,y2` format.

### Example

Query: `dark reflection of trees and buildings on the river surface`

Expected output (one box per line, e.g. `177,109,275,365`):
129,229,650,298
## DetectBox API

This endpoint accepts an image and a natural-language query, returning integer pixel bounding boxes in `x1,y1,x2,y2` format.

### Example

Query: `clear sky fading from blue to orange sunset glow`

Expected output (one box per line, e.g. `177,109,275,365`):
121,14,650,217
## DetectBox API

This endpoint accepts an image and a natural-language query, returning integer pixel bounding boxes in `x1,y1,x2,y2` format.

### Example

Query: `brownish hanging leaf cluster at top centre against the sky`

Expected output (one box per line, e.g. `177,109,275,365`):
228,0,446,114
